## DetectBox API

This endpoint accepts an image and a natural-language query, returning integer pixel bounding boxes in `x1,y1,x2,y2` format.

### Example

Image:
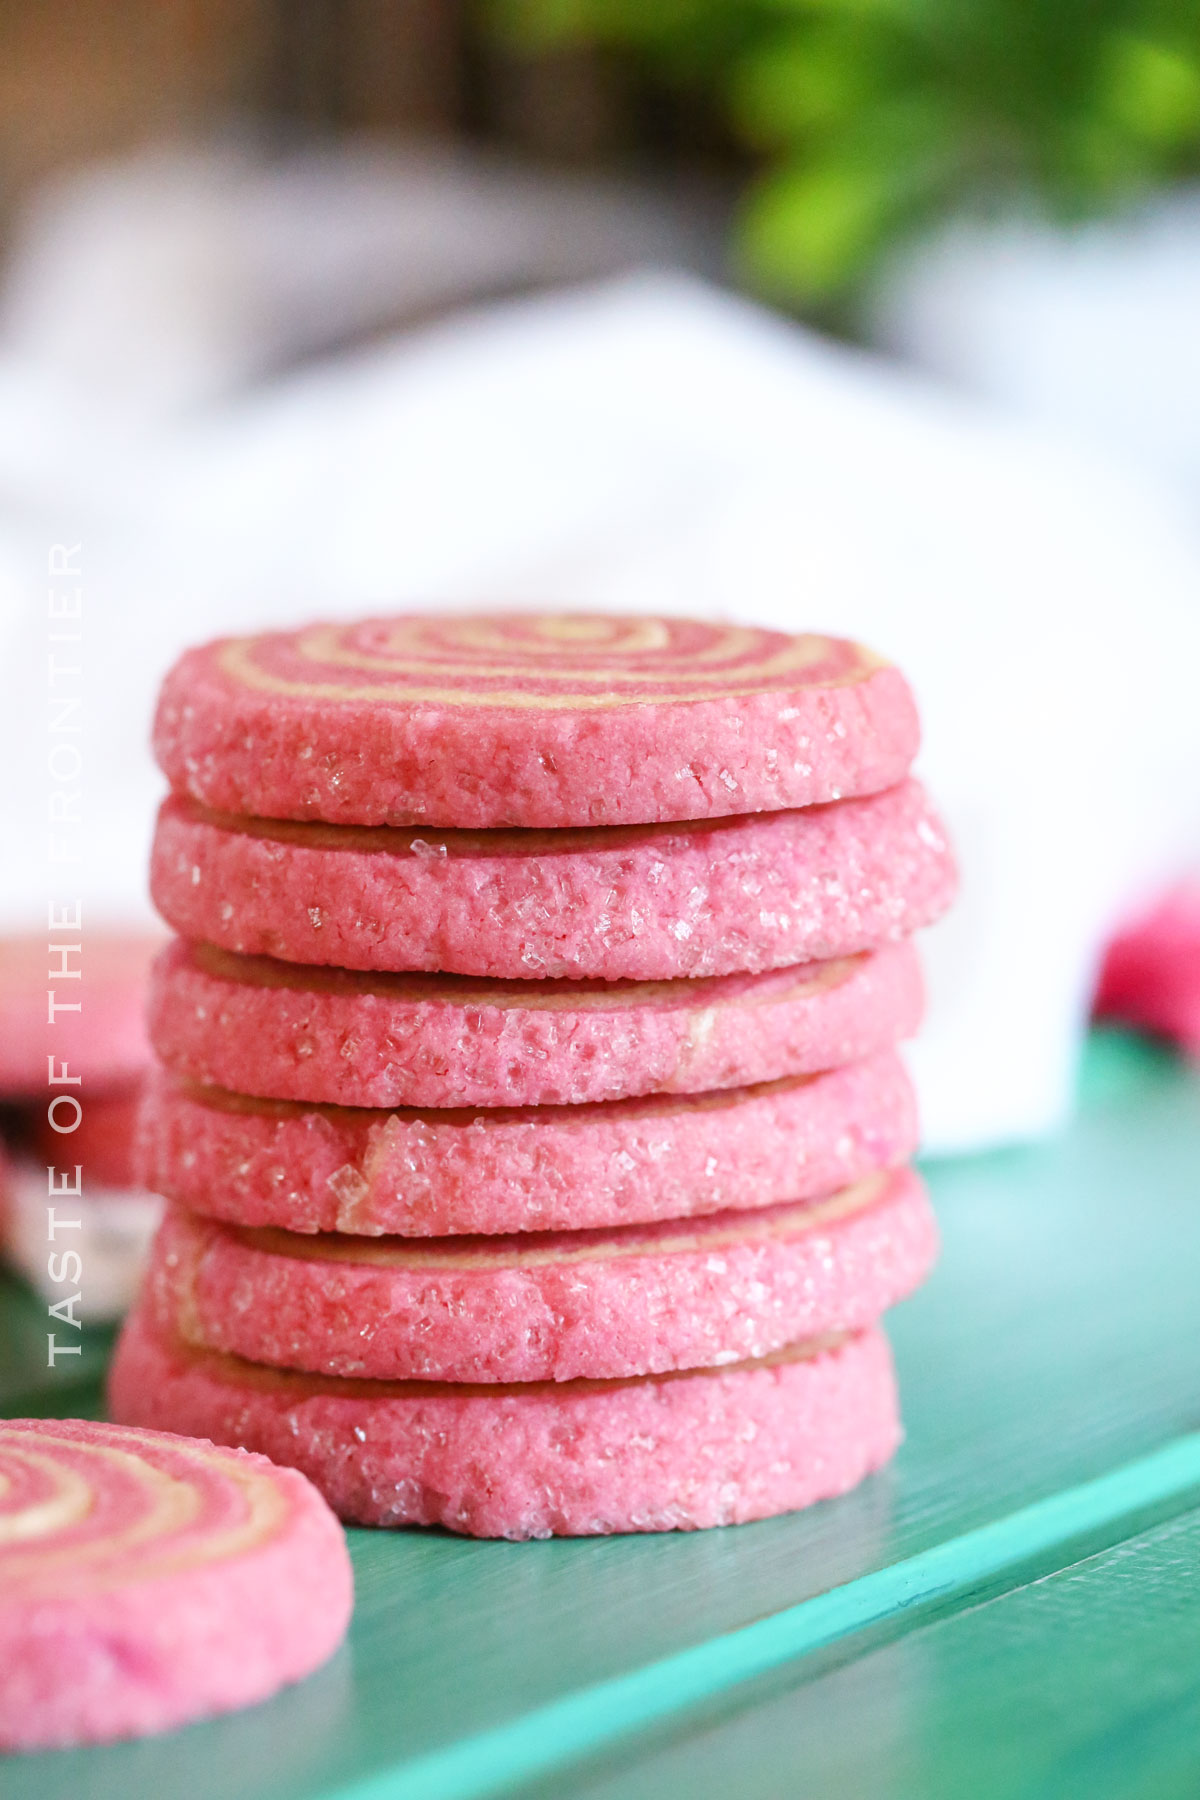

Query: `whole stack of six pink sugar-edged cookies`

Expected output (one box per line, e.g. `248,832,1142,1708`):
112,616,954,1537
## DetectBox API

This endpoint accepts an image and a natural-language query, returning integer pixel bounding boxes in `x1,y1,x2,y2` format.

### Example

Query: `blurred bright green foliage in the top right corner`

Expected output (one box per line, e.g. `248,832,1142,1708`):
489,0,1200,310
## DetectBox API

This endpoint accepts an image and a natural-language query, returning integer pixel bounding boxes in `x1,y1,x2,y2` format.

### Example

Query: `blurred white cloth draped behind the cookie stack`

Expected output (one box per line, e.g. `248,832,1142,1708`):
0,162,1200,1150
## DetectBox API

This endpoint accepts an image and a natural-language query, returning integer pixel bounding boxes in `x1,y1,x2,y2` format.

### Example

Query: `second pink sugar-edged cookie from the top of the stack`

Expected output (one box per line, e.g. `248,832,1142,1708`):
151,781,955,981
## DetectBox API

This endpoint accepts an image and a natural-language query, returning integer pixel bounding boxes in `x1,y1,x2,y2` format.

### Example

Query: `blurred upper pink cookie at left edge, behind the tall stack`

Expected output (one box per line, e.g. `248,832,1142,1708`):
0,936,162,1103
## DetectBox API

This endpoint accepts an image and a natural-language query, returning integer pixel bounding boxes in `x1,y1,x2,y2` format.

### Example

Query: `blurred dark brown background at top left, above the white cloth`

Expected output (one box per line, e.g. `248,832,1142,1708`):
0,0,719,222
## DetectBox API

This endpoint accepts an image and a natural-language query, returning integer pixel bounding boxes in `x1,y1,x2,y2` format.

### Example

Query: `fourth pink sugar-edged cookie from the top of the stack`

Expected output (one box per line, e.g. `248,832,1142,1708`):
140,1051,918,1237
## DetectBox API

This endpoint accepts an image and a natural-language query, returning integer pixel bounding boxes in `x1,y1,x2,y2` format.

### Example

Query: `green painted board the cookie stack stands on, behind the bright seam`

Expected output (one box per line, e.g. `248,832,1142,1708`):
0,1035,1200,1800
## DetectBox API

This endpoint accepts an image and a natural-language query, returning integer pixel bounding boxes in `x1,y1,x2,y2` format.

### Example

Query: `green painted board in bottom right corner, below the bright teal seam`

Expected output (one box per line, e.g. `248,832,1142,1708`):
564,1512,1200,1800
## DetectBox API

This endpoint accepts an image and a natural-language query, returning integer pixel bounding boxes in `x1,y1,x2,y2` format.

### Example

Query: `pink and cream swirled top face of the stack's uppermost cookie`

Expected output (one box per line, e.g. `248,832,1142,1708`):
216,614,883,711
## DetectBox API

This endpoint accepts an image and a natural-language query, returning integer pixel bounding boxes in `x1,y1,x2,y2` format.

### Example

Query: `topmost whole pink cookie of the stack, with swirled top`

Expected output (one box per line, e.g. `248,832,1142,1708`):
155,614,919,828
